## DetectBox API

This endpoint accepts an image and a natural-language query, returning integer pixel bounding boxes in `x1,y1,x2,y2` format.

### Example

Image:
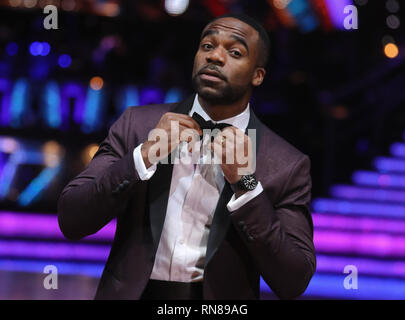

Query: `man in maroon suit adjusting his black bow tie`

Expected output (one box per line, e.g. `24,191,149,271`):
58,15,316,299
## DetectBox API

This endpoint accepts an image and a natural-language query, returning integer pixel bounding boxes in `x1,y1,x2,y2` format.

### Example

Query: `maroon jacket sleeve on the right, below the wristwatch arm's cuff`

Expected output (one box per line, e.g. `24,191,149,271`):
231,155,316,299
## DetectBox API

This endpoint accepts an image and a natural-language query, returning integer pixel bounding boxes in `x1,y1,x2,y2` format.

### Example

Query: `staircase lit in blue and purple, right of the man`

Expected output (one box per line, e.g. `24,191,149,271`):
292,134,405,299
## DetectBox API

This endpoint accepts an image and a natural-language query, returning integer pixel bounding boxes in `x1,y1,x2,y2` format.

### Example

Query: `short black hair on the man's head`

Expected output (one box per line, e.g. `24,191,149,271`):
208,13,270,68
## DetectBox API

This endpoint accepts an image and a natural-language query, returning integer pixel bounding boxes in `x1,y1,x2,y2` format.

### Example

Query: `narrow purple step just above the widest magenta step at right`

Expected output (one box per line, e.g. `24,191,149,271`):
312,213,405,235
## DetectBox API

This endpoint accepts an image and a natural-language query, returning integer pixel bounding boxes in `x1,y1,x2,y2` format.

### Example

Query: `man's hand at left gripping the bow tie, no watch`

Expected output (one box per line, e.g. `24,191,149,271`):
141,112,202,168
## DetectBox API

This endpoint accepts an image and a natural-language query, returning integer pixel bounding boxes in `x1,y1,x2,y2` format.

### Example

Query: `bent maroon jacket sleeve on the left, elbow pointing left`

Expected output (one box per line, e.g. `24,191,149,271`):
58,108,140,240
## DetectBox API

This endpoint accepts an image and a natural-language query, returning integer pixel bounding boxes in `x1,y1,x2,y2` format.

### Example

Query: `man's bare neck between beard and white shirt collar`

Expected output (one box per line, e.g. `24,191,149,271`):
198,95,249,121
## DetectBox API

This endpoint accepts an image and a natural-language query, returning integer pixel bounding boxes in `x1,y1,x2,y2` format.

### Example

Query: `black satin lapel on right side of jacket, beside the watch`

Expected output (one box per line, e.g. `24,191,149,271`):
205,109,262,267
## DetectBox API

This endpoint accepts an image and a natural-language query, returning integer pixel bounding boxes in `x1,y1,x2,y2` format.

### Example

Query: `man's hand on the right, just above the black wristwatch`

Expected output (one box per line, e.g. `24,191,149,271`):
212,126,255,184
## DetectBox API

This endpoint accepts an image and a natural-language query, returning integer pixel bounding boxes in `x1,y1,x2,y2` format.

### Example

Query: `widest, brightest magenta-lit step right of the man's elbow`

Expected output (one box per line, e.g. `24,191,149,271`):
314,230,405,258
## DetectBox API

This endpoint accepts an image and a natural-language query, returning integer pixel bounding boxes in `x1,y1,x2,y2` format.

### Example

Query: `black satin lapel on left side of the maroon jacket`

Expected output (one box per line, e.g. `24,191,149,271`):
148,95,194,252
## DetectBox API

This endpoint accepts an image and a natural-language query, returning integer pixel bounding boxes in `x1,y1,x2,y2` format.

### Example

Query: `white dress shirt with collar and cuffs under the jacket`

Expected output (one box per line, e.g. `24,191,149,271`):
133,95,263,282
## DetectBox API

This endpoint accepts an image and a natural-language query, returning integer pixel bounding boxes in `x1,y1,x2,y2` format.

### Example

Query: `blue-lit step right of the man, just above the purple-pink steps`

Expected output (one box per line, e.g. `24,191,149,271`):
312,198,405,218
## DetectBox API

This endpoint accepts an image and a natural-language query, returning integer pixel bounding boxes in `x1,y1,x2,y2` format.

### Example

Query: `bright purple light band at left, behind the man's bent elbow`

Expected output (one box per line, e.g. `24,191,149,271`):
0,211,116,241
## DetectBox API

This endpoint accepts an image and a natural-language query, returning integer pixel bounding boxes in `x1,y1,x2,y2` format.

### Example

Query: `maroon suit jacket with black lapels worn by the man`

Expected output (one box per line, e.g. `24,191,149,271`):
58,96,316,299
